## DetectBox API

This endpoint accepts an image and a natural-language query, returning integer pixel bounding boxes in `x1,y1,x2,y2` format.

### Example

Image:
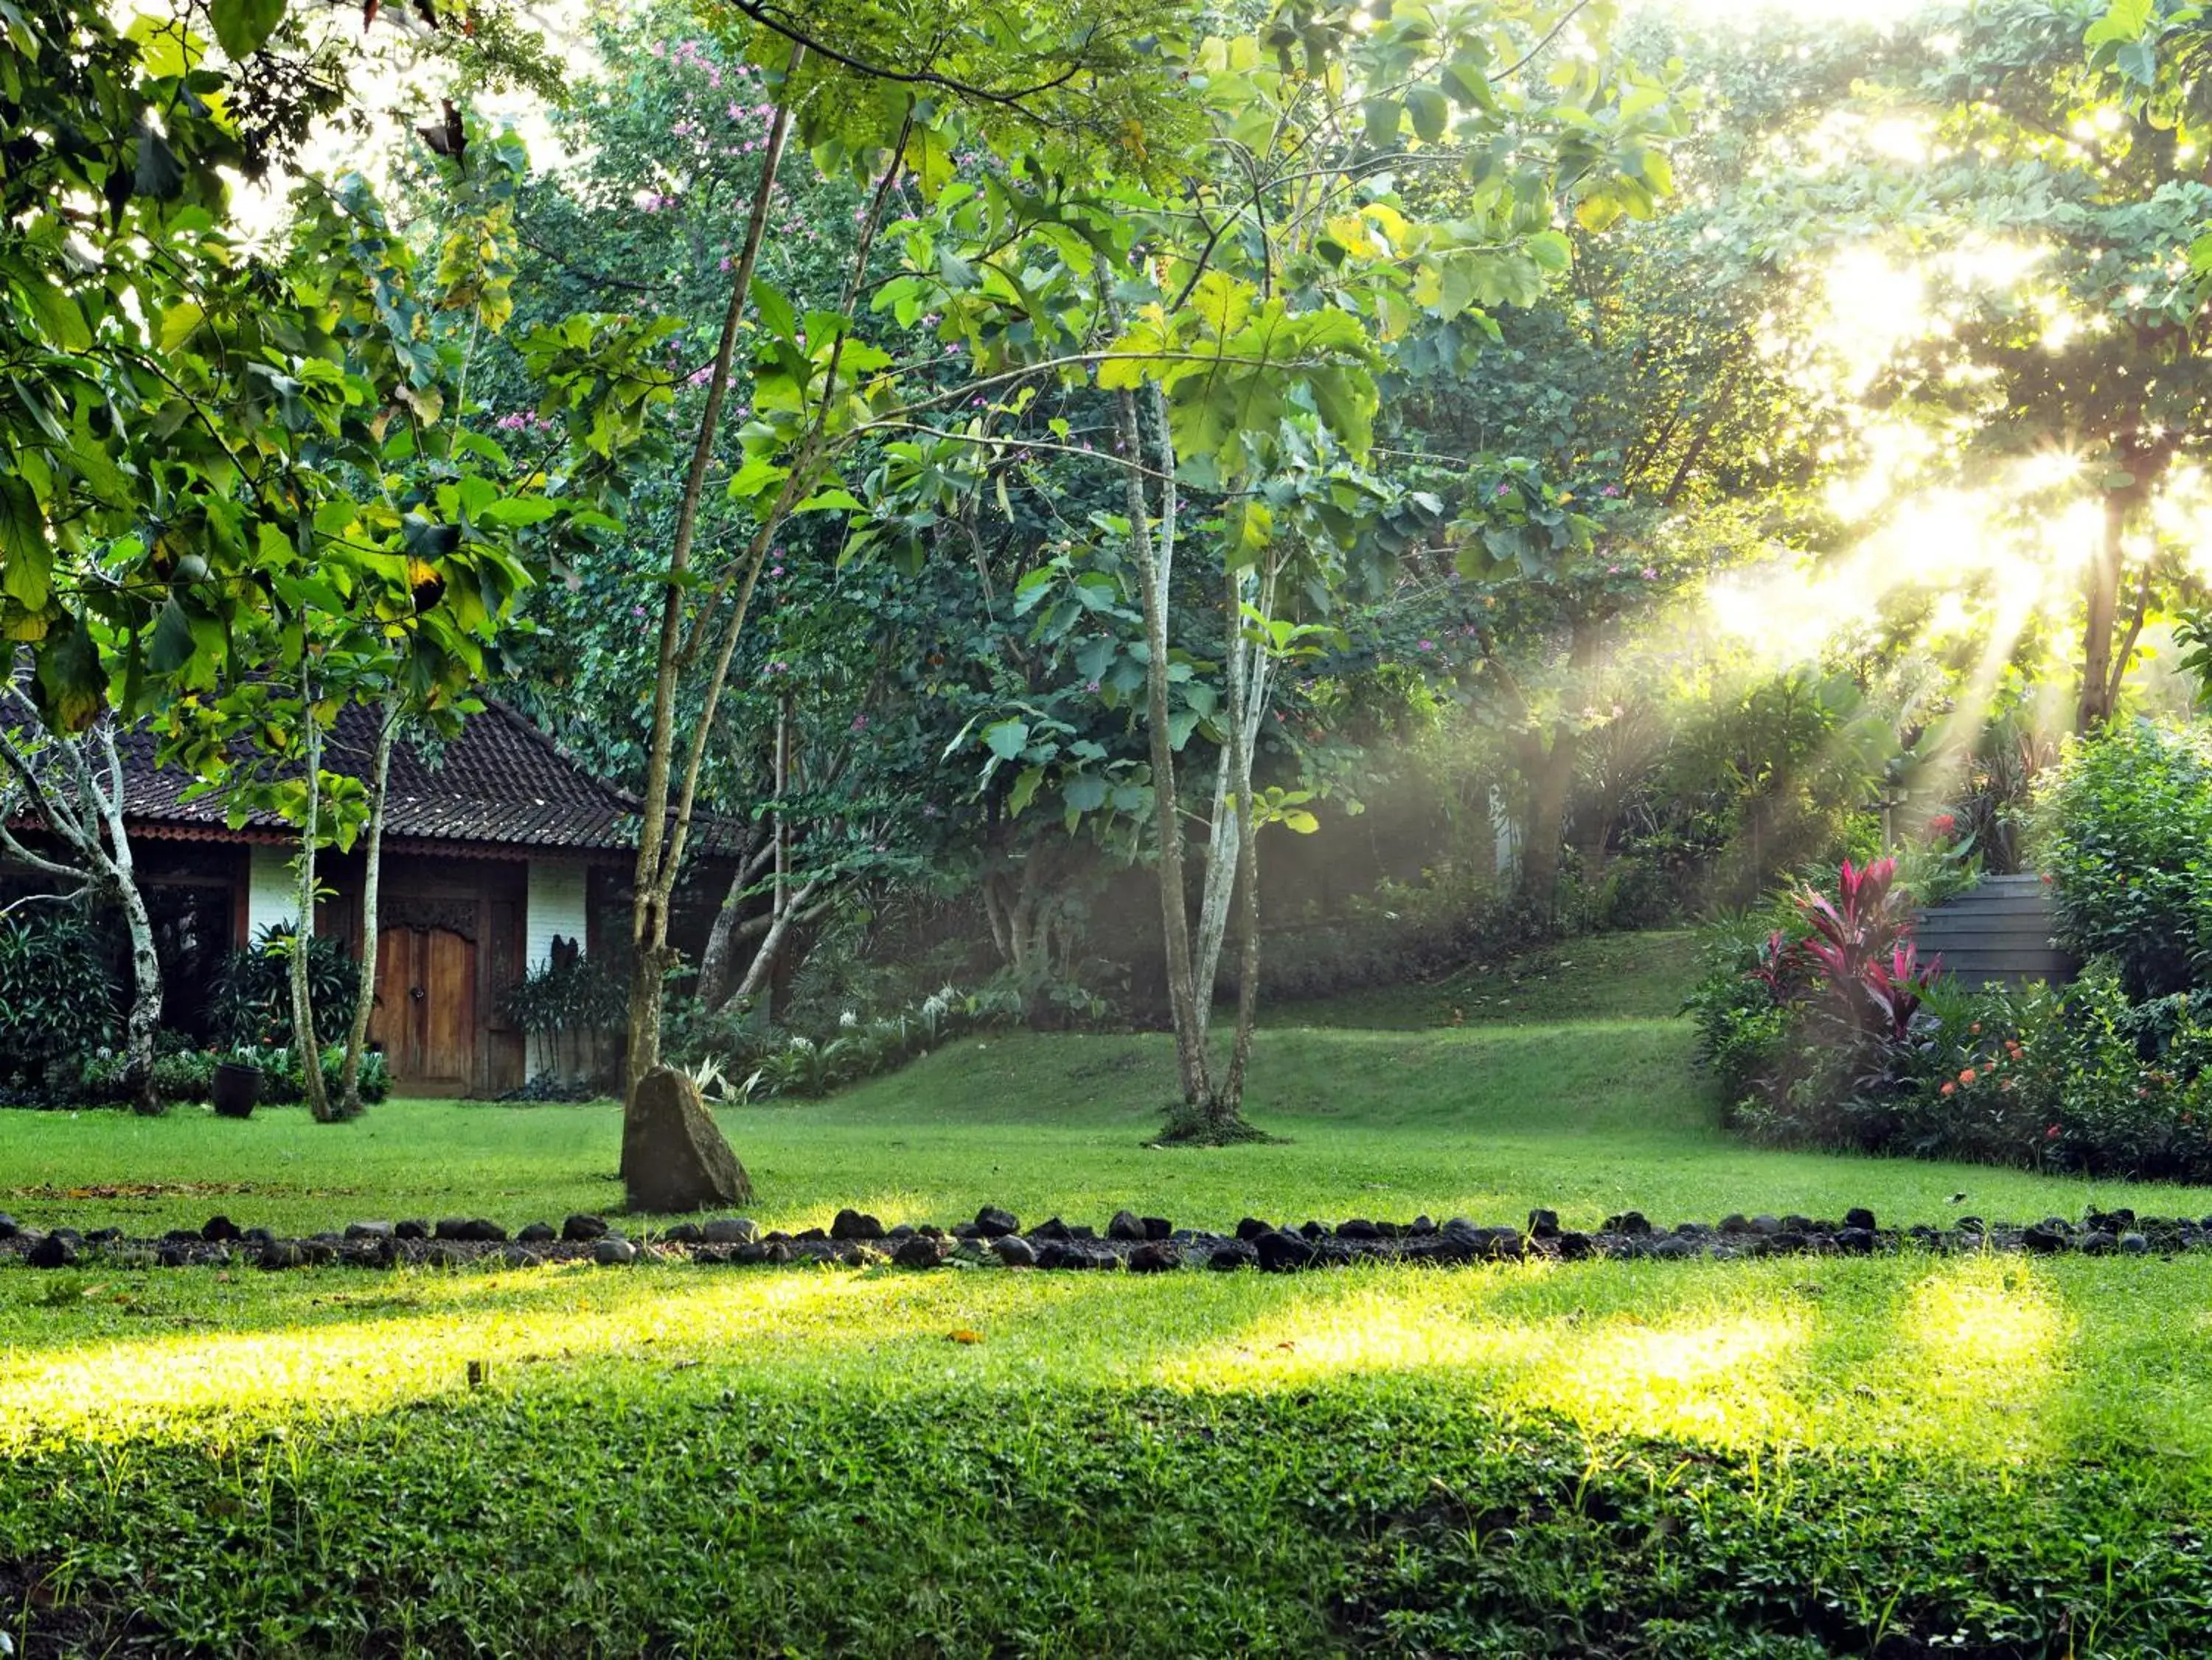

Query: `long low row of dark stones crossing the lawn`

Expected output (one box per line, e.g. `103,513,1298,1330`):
0,1204,2185,1273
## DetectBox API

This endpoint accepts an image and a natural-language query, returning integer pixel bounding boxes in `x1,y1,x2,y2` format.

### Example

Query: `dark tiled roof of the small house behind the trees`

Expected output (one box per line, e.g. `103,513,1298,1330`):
122,699,637,851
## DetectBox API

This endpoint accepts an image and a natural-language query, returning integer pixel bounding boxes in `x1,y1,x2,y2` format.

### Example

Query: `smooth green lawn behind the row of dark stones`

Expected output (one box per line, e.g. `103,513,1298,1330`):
0,935,2212,1231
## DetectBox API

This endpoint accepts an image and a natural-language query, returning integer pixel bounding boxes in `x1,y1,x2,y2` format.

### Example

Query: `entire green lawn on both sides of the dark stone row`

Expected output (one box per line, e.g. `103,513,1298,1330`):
13,939,2212,1660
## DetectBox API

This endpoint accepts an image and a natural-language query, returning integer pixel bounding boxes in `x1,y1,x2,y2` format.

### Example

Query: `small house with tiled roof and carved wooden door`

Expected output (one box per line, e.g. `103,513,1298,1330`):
102,699,637,1096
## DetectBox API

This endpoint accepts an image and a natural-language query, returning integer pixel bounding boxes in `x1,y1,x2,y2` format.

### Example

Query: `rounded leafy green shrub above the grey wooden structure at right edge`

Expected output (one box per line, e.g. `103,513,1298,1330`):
2037,721,2212,999
